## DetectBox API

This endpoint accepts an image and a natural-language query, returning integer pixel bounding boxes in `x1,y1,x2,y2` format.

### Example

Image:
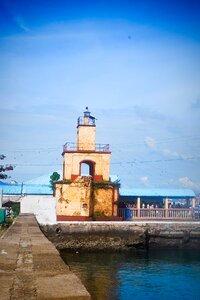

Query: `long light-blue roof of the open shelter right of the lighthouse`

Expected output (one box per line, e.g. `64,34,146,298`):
120,188,196,198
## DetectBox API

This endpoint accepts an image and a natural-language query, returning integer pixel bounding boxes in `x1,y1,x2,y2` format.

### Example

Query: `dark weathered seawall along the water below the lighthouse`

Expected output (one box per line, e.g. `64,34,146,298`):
41,221,200,251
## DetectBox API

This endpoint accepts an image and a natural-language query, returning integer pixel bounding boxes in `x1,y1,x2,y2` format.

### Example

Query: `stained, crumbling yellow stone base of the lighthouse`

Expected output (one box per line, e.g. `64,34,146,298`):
55,176,119,220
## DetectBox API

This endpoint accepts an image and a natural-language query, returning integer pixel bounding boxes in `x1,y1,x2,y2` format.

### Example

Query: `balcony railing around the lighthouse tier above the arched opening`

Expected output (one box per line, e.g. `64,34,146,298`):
63,142,110,152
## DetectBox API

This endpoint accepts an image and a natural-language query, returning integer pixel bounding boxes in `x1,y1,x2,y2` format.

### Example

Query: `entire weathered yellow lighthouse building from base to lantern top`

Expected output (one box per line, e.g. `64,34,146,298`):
54,107,119,221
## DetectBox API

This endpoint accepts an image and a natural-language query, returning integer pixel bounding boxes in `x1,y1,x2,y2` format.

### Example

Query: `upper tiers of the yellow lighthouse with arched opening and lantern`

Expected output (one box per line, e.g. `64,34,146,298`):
63,107,111,181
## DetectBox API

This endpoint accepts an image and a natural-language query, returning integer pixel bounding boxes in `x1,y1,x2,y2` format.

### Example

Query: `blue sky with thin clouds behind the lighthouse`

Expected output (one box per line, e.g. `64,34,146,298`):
0,0,200,191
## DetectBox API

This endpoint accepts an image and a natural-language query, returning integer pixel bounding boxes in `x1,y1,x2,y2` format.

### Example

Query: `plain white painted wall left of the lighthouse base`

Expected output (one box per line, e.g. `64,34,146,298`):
20,195,57,225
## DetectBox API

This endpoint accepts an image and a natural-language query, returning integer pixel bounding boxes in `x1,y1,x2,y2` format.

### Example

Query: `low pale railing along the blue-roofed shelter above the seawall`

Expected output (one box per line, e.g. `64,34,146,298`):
118,208,200,220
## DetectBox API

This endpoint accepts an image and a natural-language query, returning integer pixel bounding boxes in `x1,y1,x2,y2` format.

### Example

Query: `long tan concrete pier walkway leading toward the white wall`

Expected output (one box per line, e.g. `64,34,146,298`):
0,215,91,300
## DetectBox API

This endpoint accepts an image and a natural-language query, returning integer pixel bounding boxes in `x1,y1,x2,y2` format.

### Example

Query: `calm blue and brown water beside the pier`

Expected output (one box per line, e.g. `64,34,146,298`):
61,250,200,300
